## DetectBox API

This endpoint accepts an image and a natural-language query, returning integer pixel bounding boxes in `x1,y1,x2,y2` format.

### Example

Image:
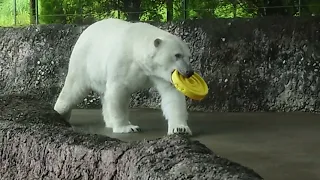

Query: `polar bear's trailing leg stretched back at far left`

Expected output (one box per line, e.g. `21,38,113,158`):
54,76,89,121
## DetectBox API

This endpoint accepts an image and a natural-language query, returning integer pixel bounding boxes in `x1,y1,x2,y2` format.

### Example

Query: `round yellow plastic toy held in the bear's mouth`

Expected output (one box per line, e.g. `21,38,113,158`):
171,70,209,100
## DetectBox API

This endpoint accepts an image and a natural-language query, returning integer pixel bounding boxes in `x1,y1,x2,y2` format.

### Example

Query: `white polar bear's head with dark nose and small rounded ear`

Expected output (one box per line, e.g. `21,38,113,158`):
141,35,194,82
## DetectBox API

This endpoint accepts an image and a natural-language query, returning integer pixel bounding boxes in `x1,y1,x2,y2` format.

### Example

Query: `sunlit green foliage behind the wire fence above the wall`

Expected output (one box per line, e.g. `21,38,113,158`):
0,0,320,26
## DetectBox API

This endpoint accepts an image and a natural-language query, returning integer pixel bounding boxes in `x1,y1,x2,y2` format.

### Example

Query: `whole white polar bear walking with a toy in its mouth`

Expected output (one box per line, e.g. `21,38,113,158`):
54,18,194,135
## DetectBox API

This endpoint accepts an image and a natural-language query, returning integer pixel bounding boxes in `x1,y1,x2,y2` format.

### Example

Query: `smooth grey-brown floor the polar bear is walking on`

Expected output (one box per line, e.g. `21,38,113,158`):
71,110,320,180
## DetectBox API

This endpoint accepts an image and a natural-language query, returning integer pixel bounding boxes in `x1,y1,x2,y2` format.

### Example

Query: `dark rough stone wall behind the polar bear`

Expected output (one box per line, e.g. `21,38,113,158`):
0,17,320,112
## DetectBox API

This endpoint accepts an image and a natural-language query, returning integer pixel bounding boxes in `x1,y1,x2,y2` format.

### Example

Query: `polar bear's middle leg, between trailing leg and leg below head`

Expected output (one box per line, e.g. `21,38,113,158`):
102,85,140,133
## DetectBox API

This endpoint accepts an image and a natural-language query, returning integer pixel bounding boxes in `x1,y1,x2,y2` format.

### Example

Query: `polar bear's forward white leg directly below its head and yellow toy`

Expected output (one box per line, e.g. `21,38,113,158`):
156,82,192,135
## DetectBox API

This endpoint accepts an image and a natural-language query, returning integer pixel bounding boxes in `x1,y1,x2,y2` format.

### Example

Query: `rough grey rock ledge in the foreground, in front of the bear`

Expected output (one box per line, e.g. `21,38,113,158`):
0,95,262,180
